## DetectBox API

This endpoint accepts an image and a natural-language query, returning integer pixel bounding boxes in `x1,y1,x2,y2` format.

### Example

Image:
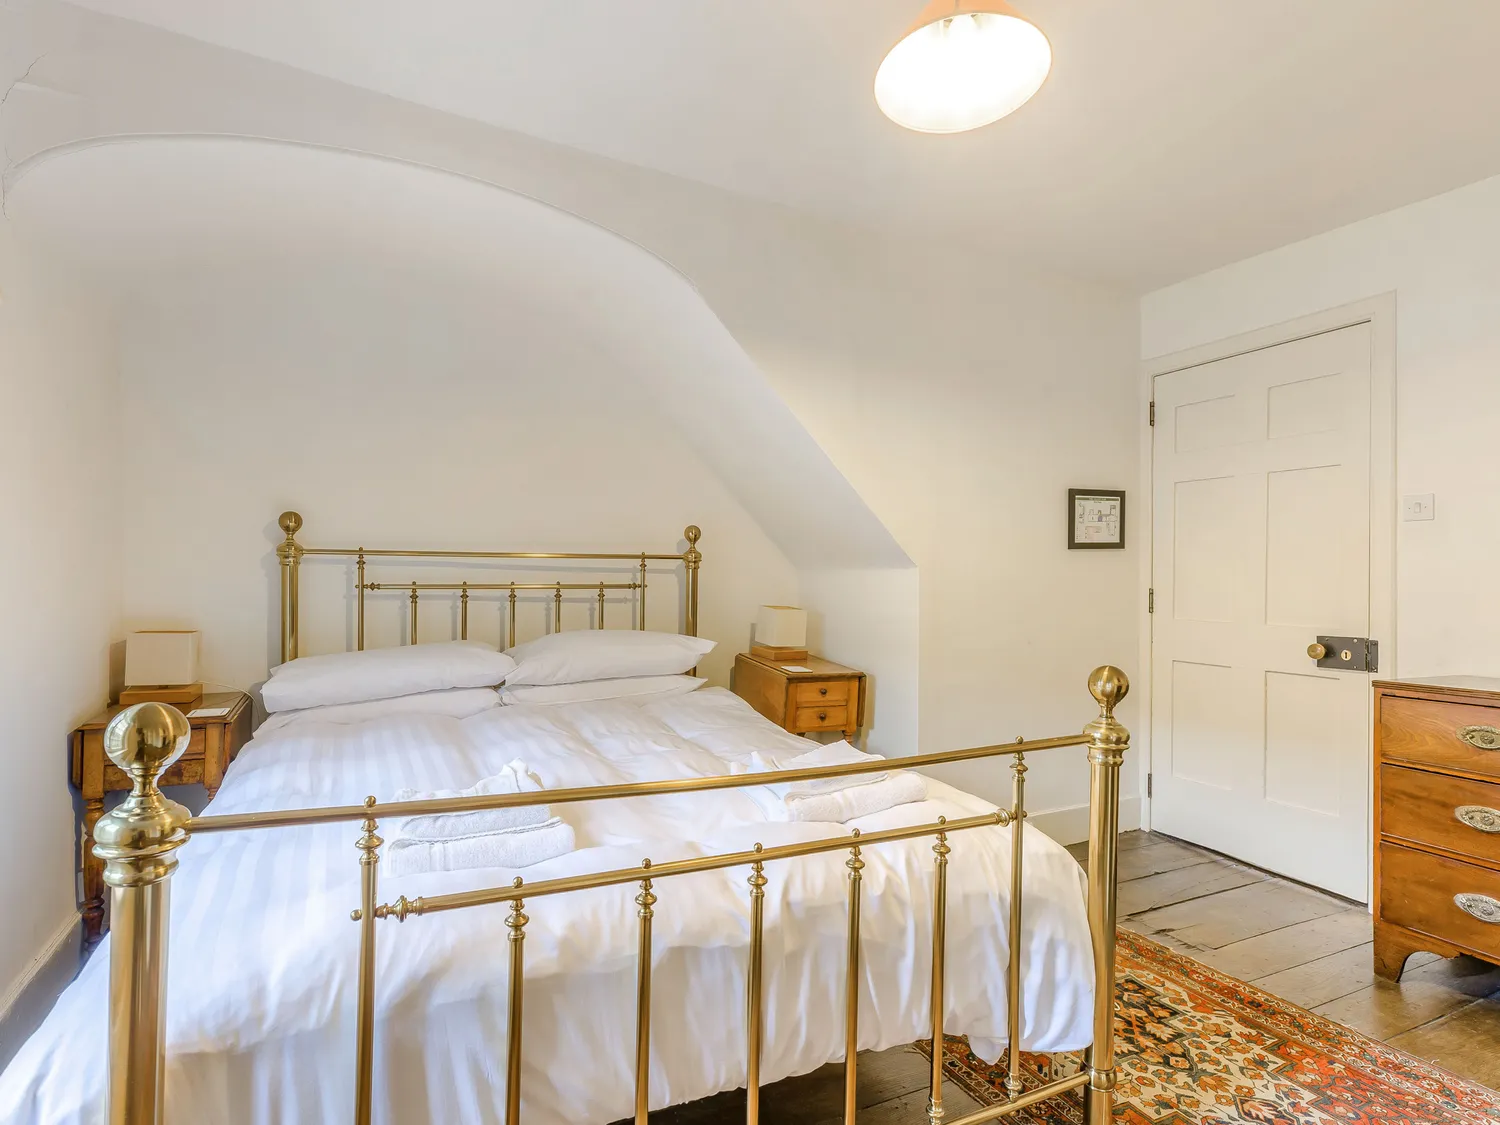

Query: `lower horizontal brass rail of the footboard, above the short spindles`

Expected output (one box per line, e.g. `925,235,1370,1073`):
375,809,1011,921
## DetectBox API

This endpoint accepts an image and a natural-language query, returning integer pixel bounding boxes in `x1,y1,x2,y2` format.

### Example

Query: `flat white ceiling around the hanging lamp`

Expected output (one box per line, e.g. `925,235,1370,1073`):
46,0,1500,290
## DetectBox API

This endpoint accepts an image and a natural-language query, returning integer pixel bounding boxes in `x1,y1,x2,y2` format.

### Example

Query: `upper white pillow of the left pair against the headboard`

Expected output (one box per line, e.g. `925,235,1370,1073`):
261,641,516,711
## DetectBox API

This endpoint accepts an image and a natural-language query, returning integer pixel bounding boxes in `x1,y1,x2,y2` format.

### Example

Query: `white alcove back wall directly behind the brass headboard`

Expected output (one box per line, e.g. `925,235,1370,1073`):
122,268,798,689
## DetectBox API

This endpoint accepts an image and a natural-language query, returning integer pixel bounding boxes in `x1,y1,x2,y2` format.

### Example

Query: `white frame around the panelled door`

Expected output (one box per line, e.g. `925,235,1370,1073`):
1136,291,1398,906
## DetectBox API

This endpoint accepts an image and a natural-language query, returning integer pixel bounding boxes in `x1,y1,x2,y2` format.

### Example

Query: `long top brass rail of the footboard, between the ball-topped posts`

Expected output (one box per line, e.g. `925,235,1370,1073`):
188,734,1089,833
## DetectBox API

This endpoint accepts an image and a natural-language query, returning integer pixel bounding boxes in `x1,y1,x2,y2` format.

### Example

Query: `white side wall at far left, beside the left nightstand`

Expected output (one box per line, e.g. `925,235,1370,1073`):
0,221,118,1058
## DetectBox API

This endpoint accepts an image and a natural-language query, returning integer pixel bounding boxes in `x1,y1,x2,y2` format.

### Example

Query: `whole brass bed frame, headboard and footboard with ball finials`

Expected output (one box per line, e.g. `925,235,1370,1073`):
95,512,1130,1125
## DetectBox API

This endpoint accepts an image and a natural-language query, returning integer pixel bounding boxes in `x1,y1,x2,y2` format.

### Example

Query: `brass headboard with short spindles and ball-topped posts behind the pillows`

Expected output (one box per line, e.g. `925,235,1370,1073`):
276,512,704,663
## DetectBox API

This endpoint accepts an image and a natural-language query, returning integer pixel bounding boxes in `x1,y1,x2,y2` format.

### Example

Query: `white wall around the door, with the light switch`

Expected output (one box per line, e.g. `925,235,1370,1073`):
1142,179,1500,677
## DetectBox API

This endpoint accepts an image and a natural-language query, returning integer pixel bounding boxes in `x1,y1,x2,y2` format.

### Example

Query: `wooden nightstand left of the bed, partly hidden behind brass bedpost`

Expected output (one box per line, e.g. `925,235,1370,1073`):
72,692,251,945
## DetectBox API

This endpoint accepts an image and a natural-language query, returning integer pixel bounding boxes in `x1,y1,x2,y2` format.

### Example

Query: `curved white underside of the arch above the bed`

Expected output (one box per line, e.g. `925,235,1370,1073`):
6,137,911,567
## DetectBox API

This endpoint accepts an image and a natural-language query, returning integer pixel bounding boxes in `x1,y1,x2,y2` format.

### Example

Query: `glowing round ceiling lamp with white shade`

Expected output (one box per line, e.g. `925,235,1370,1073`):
875,0,1052,134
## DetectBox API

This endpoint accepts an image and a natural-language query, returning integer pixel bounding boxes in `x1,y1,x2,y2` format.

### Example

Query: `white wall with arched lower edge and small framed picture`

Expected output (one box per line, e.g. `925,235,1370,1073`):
9,8,1142,822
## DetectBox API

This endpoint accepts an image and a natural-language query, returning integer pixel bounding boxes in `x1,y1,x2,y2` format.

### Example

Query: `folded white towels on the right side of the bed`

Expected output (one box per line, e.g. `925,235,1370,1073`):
731,743,927,824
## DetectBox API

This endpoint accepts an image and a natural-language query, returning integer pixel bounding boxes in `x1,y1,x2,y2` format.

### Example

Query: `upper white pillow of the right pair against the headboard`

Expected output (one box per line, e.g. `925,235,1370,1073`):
506,629,714,686
